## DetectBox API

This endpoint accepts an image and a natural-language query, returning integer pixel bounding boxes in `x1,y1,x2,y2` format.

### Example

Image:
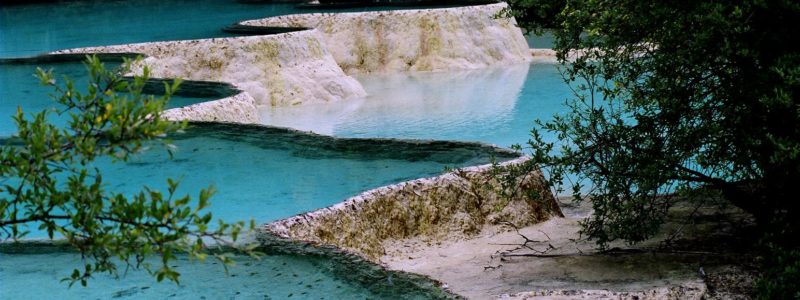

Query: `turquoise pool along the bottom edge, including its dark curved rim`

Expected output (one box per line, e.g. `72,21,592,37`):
0,243,457,299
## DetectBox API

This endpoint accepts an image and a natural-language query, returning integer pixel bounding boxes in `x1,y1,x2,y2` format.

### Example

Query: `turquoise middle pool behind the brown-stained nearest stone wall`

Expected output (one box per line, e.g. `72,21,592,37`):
95,125,506,231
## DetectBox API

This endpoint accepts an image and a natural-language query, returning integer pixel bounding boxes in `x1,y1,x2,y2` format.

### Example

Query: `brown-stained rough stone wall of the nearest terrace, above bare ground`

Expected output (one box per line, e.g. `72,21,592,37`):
260,157,560,262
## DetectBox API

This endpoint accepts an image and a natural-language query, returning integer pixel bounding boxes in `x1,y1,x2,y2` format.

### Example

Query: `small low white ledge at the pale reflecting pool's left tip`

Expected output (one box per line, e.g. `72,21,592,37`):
161,92,259,124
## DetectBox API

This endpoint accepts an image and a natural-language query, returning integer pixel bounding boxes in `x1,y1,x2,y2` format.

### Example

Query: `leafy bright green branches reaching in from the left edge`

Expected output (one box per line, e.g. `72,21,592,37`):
0,57,252,285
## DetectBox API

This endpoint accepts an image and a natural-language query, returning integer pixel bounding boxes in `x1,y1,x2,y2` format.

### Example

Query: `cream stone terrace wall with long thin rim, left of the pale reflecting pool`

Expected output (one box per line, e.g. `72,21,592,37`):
54,30,365,106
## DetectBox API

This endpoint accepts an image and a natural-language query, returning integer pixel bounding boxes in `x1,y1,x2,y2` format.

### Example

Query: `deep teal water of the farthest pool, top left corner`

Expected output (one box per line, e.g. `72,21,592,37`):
0,0,296,57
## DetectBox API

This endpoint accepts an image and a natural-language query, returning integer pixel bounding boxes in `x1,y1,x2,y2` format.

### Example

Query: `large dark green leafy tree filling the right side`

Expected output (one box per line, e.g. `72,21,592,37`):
511,0,800,298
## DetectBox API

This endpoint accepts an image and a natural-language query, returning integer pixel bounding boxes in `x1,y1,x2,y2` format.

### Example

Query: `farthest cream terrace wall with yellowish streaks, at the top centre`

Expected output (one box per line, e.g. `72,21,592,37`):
239,3,530,74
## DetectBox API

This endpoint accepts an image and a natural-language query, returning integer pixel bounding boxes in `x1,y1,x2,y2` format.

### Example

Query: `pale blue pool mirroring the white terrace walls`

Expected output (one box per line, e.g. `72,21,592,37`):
261,64,571,147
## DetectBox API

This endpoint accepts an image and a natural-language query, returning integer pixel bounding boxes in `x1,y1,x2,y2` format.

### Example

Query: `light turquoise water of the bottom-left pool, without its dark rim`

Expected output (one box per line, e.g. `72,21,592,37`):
0,253,374,300
